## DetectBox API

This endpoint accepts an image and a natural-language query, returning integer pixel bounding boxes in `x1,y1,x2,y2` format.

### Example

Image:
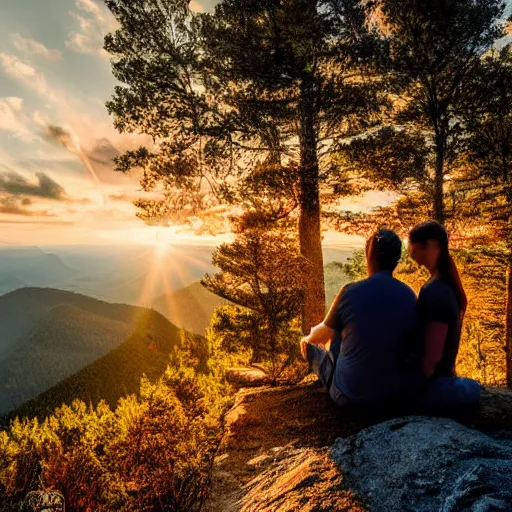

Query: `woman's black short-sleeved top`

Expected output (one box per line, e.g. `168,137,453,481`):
418,277,460,377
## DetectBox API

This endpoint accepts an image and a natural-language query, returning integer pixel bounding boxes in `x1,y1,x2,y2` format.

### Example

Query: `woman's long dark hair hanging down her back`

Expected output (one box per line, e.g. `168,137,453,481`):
409,220,467,310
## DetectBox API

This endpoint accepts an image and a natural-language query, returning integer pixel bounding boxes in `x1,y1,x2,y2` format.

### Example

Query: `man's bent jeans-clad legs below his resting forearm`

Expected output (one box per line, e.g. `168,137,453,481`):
306,334,349,406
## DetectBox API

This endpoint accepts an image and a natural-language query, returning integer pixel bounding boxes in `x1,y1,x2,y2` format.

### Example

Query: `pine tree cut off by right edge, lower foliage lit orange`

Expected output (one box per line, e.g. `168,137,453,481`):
459,46,512,387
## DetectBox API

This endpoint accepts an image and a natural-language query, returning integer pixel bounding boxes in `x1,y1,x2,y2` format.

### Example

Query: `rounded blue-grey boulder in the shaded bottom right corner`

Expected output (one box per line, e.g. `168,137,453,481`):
331,416,512,512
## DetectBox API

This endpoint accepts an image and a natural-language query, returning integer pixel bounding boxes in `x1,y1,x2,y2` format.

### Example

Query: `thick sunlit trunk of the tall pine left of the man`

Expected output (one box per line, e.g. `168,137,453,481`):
298,73,325,334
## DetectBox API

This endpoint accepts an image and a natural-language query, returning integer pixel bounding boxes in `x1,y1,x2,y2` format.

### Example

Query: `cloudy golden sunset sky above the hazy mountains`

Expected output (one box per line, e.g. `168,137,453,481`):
0,0,490,245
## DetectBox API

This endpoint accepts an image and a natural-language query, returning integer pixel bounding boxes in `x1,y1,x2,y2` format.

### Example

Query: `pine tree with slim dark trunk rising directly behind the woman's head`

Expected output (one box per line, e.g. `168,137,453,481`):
334,0,504,228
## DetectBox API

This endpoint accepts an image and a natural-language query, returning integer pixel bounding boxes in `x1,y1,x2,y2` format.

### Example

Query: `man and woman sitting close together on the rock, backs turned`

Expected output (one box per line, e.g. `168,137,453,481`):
301,221,480,410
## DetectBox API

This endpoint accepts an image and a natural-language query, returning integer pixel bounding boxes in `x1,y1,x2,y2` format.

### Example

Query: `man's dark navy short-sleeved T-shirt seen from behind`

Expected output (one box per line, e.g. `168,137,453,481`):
324,272,417,404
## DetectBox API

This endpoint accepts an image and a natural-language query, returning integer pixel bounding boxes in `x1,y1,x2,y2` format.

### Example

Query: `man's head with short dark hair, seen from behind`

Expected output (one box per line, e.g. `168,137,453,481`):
366,229,402,275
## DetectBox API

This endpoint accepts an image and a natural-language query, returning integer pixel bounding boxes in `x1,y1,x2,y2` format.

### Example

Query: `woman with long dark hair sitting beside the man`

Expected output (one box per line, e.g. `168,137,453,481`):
409,221,481,409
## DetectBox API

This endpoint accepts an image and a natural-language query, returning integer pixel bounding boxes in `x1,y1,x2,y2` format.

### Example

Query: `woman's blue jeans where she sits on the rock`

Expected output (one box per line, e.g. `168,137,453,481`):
421,377,482,410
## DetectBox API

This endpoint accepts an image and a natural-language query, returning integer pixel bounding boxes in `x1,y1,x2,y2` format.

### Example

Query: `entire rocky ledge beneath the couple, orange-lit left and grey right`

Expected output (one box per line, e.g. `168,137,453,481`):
205,383,512,512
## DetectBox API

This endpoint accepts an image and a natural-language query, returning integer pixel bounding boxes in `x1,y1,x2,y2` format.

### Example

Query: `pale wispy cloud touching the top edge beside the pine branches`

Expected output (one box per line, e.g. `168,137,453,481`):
65,0,117,57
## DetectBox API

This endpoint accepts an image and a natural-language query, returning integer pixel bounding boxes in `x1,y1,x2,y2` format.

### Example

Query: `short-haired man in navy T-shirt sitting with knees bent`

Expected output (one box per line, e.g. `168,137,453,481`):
300,229,417,406
